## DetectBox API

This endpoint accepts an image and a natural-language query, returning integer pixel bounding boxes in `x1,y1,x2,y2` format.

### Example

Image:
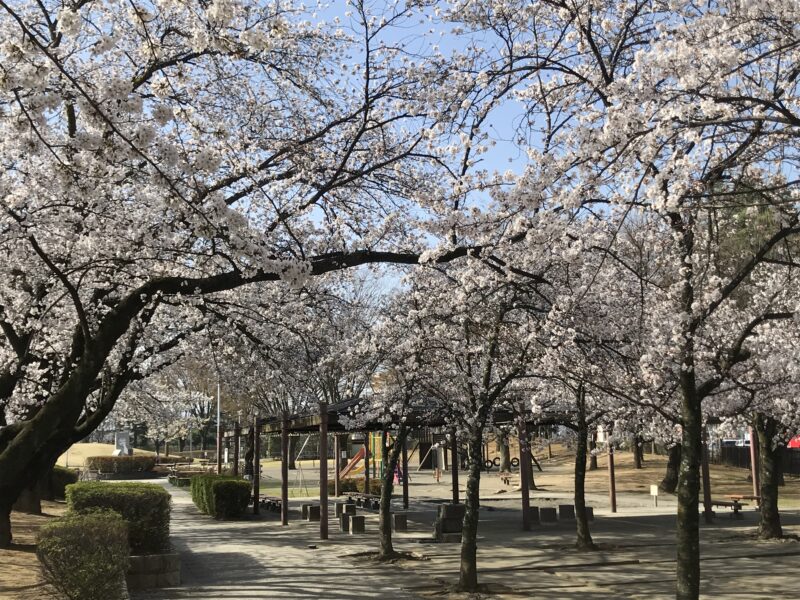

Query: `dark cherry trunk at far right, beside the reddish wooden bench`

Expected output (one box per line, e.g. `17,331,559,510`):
754,413,783,540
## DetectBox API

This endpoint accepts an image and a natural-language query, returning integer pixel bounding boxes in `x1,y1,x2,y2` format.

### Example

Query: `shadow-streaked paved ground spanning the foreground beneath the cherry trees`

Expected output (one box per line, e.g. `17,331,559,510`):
133,486,800,600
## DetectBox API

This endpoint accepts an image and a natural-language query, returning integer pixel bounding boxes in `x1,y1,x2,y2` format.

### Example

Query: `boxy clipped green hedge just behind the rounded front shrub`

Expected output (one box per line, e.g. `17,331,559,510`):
67,481,172,554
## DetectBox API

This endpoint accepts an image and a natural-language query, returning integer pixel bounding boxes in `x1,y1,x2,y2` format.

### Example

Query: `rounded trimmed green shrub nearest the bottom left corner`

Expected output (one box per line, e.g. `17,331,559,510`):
36,510,130,600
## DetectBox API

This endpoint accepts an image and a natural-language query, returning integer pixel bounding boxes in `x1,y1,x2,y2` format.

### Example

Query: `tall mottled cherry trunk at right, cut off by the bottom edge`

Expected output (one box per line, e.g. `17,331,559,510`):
676,384,702,600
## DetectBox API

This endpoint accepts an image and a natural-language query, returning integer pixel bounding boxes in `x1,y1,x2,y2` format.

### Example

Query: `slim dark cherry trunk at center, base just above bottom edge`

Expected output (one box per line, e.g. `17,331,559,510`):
458,427,483,592
